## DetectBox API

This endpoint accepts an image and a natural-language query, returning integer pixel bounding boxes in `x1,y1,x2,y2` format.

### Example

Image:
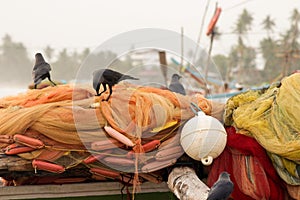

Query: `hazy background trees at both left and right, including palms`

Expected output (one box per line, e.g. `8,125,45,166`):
0,9,300,85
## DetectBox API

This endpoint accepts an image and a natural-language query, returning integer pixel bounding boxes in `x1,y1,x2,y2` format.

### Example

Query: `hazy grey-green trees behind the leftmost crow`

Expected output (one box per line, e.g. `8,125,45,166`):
0,34,125,86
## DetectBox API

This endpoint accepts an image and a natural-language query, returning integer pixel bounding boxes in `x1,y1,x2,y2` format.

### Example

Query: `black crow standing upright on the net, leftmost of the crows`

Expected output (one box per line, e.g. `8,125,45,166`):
32,53,56,89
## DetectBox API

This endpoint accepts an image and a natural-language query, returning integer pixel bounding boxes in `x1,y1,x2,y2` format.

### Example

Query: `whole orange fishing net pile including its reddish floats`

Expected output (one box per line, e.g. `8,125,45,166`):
0,83,223,188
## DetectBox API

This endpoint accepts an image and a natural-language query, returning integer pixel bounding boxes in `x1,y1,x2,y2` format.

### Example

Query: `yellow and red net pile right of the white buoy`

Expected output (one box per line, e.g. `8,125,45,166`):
208,73,300,199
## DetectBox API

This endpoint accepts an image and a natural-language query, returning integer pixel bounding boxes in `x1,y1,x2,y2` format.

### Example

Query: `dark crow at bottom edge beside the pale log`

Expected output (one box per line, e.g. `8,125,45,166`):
207,172,233,200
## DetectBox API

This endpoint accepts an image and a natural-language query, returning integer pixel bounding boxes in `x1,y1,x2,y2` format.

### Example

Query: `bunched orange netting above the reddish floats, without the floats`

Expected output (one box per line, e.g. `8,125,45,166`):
0,84,212,147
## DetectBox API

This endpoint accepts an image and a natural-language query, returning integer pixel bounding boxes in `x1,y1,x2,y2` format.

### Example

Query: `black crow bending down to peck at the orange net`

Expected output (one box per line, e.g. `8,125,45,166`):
93,69,138,101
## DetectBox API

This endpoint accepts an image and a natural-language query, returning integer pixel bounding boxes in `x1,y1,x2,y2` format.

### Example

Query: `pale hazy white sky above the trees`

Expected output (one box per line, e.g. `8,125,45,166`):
0,0,300,57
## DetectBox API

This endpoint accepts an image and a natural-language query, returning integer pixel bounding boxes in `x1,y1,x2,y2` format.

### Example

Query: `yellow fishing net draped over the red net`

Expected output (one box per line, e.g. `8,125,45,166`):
224,73,300,185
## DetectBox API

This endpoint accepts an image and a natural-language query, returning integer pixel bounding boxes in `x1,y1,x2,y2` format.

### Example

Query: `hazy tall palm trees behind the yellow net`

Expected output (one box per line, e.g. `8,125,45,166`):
213,9,300,85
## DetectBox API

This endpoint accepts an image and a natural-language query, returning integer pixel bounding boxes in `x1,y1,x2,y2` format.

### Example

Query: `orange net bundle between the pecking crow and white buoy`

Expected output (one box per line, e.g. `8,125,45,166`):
100,86,212,138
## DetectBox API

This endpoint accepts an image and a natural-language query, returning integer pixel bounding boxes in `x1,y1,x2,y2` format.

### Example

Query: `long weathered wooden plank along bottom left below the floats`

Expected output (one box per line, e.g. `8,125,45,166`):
0,182,170,200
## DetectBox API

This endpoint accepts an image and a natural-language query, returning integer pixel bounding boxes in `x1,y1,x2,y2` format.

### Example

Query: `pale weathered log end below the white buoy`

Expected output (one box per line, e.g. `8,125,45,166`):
168,167,210,200
